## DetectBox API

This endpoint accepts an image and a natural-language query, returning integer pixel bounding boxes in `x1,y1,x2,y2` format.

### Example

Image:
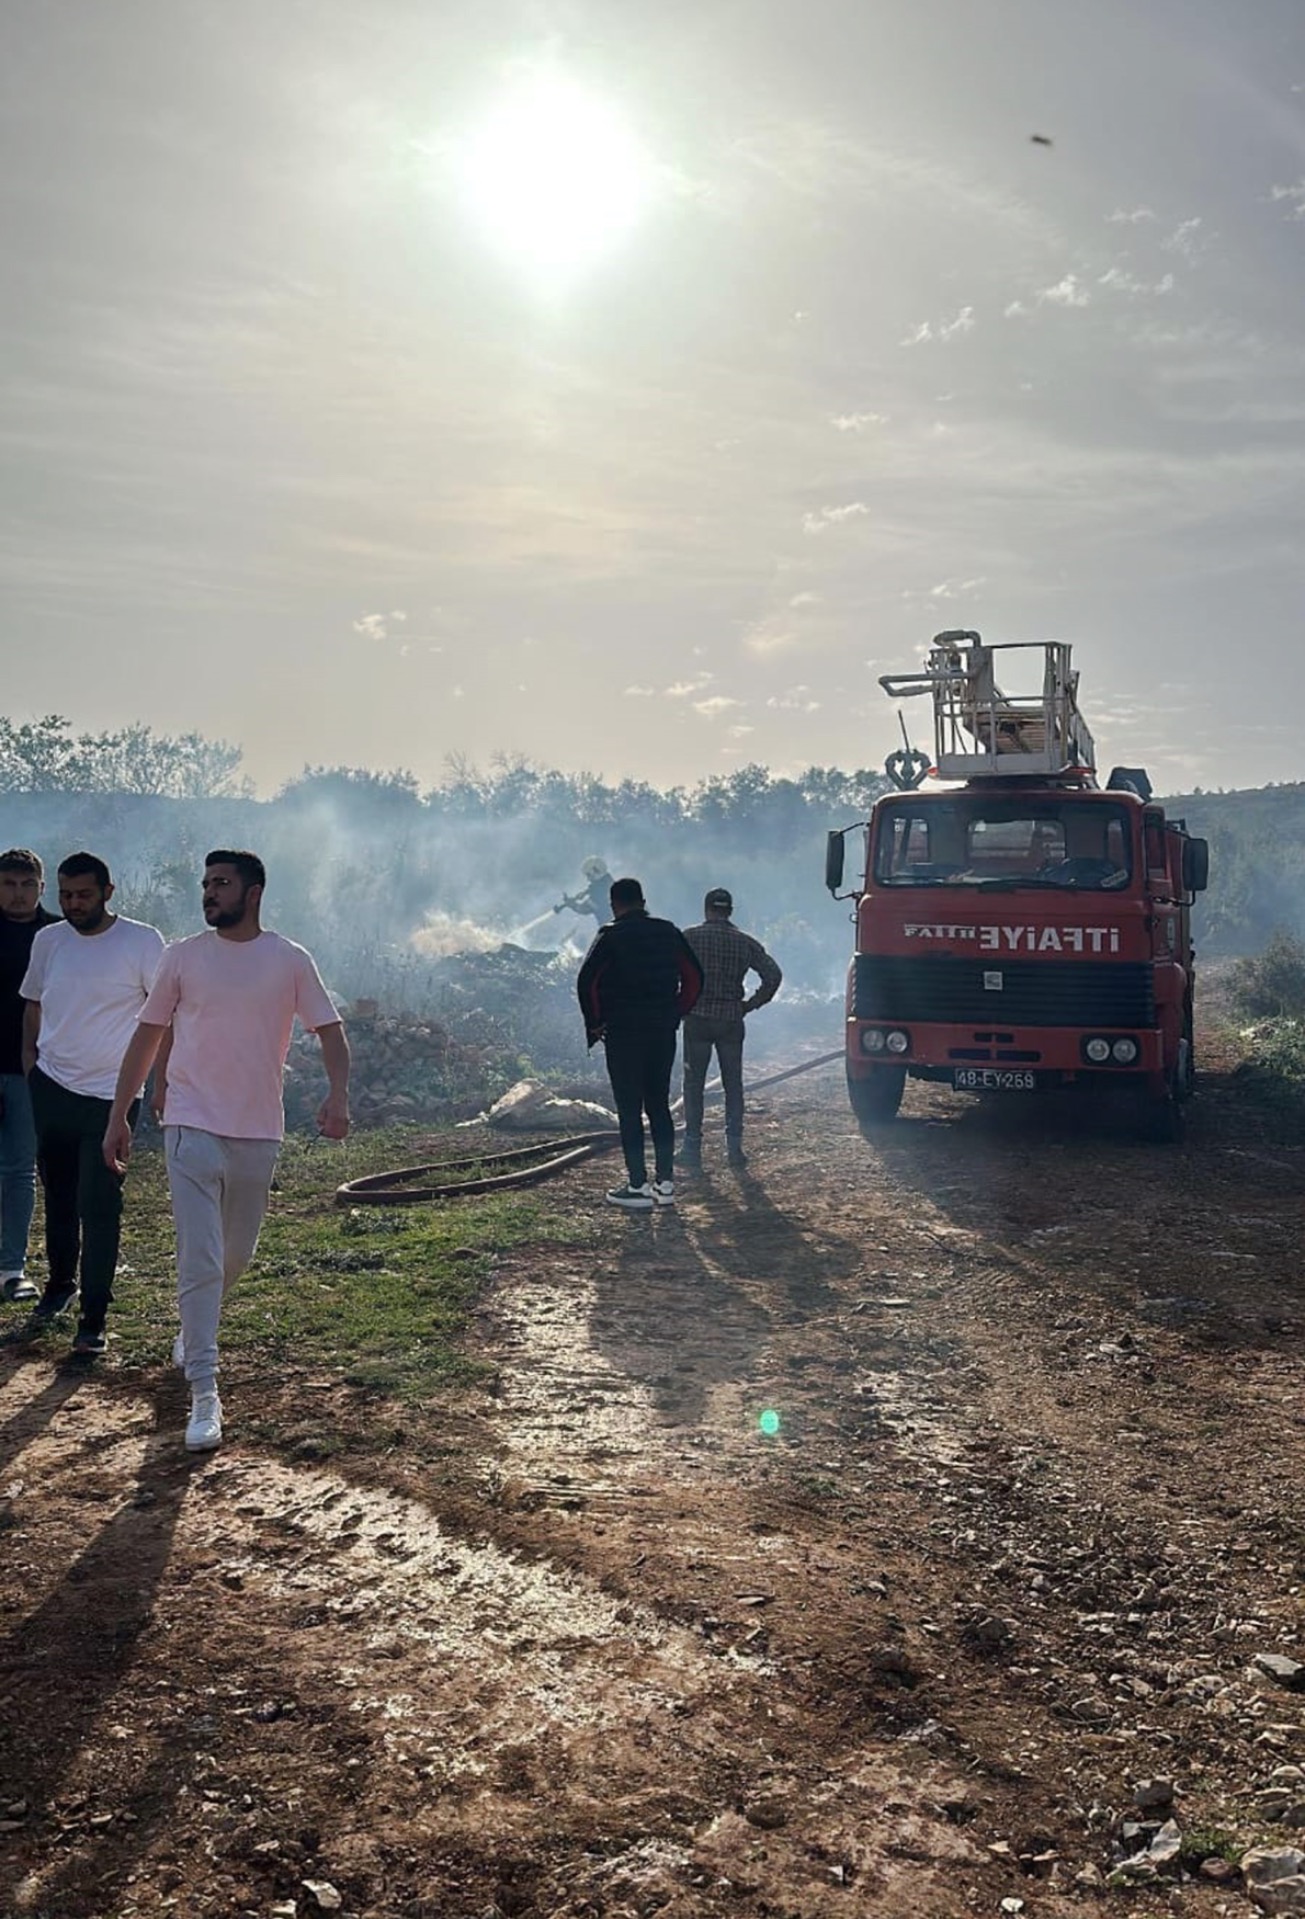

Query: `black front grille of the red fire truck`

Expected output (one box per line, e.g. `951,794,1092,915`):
852,954,1155,1027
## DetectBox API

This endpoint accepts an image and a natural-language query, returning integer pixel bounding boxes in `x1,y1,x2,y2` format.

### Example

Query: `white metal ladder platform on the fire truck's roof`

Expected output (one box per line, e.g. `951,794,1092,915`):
879,631,1096,785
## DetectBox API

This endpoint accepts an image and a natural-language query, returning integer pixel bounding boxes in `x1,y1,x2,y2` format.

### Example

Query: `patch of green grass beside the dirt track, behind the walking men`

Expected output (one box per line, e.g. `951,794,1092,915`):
73,1128,585,1401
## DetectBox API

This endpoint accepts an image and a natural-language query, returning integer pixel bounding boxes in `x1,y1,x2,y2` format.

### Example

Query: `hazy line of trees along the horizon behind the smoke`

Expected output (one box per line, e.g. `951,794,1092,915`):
0,714,1305,967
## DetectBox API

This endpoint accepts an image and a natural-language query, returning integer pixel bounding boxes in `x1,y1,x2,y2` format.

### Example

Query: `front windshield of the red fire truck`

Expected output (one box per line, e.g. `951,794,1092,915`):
873,793,1132,892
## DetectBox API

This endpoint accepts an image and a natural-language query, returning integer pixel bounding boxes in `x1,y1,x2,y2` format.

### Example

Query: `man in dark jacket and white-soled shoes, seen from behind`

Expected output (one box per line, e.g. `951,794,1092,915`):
576,879,702,1213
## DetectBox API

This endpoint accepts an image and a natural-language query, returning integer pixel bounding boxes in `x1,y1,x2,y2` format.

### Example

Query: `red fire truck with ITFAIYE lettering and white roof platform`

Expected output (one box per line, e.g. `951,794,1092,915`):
825,631,1209,1140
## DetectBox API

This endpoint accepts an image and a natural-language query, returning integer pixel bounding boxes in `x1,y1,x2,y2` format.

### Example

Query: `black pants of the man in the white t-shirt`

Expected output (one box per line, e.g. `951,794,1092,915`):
29,1067,140,1332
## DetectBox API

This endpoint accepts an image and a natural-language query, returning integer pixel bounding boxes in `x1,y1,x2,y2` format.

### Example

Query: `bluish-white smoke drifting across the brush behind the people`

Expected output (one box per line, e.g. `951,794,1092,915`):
6,764,890,1067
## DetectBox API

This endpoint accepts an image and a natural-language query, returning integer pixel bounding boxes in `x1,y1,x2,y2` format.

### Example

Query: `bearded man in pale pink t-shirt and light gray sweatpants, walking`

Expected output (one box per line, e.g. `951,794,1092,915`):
104,848,349,1453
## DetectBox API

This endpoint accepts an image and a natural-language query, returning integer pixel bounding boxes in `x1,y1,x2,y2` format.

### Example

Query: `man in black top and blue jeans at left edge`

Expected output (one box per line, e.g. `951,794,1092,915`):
0,846,58,1303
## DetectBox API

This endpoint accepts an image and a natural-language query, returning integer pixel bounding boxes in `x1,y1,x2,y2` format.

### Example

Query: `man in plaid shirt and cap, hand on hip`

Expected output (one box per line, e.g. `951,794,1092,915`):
679,887,783,1173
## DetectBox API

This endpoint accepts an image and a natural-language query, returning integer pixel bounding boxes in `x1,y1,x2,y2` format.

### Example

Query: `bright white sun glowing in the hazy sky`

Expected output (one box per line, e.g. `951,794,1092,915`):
459,75,653,276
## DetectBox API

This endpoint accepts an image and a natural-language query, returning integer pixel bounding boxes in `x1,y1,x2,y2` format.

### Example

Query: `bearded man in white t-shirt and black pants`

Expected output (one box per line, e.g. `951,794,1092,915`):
19,852,163,1357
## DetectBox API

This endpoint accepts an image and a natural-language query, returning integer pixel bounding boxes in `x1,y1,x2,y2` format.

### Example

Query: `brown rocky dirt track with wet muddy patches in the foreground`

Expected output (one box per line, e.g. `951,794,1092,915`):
0,1043,1305,1919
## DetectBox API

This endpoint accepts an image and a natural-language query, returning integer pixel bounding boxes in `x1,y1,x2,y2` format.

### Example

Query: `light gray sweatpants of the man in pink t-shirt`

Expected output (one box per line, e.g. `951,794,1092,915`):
163,1126,280,1389
